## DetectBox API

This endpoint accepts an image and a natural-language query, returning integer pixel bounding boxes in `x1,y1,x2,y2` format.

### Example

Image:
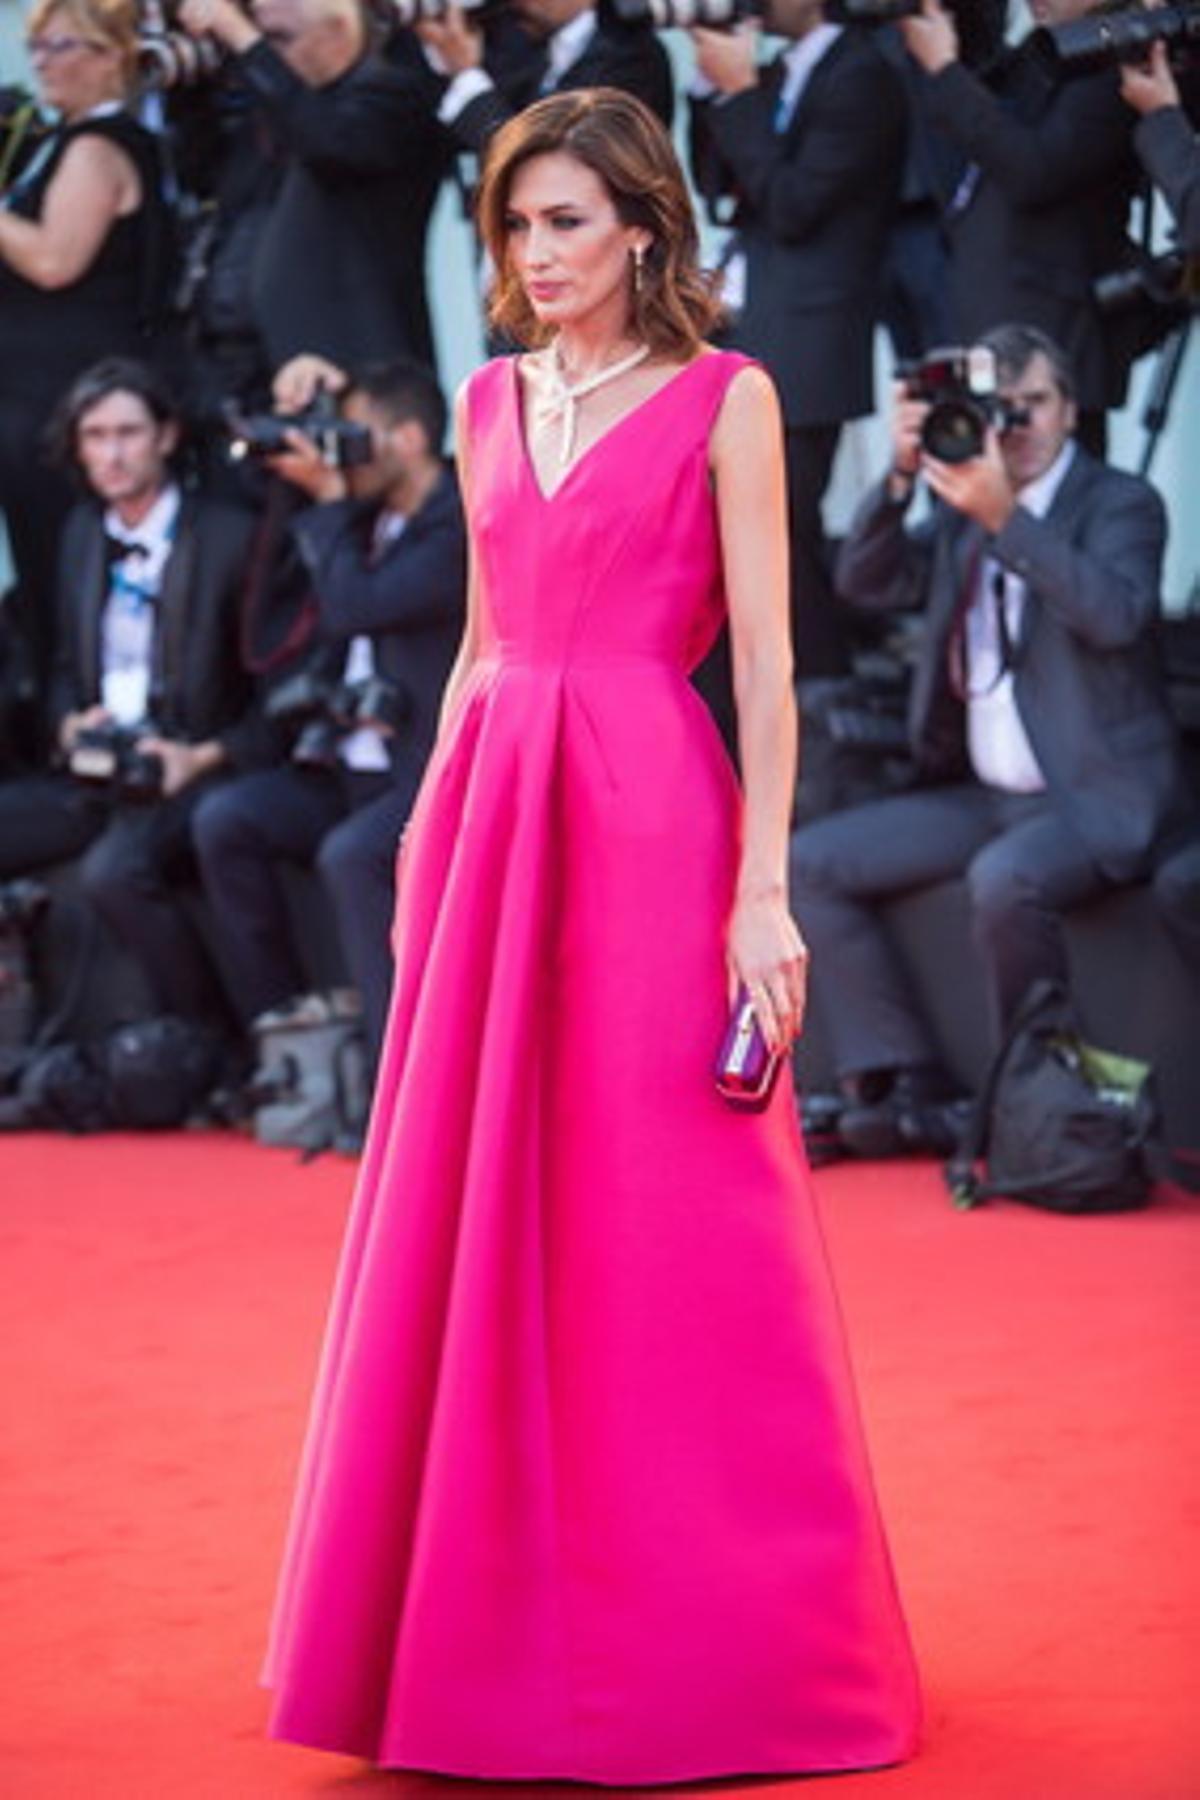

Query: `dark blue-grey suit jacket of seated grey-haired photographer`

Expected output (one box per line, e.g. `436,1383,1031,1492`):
837,445,1189,880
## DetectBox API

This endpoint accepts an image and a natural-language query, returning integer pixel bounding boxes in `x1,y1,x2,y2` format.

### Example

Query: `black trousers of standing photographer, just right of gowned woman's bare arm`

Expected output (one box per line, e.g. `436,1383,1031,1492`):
784,425,849,680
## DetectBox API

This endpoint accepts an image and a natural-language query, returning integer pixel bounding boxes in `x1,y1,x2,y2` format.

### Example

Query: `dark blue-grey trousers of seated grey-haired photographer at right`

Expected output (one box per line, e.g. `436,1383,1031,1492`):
792,781,1108,1075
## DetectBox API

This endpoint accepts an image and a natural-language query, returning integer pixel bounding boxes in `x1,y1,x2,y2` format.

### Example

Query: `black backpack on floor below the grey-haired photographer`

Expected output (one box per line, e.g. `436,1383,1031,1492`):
945,981,1195,1213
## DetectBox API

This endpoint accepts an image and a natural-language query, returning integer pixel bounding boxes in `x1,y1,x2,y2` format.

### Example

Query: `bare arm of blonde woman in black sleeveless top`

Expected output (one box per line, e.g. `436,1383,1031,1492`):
0,133,142,288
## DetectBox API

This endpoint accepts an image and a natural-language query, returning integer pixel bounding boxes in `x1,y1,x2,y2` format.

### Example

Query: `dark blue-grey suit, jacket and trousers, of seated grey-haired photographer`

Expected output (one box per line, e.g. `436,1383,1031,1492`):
792,448,1189,1075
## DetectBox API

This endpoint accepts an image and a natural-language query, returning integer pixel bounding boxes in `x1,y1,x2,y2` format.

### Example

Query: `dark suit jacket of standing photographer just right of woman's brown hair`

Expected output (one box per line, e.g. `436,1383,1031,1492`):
693,31,905,427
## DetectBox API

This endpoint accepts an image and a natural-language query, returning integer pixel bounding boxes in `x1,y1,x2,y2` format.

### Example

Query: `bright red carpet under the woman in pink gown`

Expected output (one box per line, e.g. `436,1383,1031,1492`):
0,1136,1200,1800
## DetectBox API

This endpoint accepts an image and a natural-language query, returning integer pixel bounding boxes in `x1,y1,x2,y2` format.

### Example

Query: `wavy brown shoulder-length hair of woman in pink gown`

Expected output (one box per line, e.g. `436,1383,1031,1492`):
479,88,721,358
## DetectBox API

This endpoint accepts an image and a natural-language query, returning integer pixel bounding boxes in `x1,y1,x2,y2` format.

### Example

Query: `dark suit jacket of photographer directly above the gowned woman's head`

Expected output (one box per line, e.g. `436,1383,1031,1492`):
450,20,675,155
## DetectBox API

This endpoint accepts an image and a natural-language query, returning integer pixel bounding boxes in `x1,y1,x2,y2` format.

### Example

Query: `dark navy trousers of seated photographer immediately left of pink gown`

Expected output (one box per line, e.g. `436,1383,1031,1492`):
196,765,414,1060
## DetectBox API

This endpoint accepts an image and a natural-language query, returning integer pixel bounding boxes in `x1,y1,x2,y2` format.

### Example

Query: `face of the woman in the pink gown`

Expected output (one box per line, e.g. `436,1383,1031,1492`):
506,151,649,329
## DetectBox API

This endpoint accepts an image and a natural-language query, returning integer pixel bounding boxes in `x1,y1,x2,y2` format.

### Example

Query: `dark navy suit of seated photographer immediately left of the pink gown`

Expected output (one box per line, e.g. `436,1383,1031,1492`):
196,470,466,1053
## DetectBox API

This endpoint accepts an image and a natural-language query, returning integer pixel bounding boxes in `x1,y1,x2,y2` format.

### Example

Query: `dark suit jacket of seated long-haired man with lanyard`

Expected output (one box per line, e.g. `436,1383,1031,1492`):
50,495,272,769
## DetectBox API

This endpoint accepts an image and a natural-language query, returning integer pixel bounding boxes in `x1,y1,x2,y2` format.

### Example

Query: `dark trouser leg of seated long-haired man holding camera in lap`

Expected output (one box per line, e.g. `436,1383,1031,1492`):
79,776,227,1028
